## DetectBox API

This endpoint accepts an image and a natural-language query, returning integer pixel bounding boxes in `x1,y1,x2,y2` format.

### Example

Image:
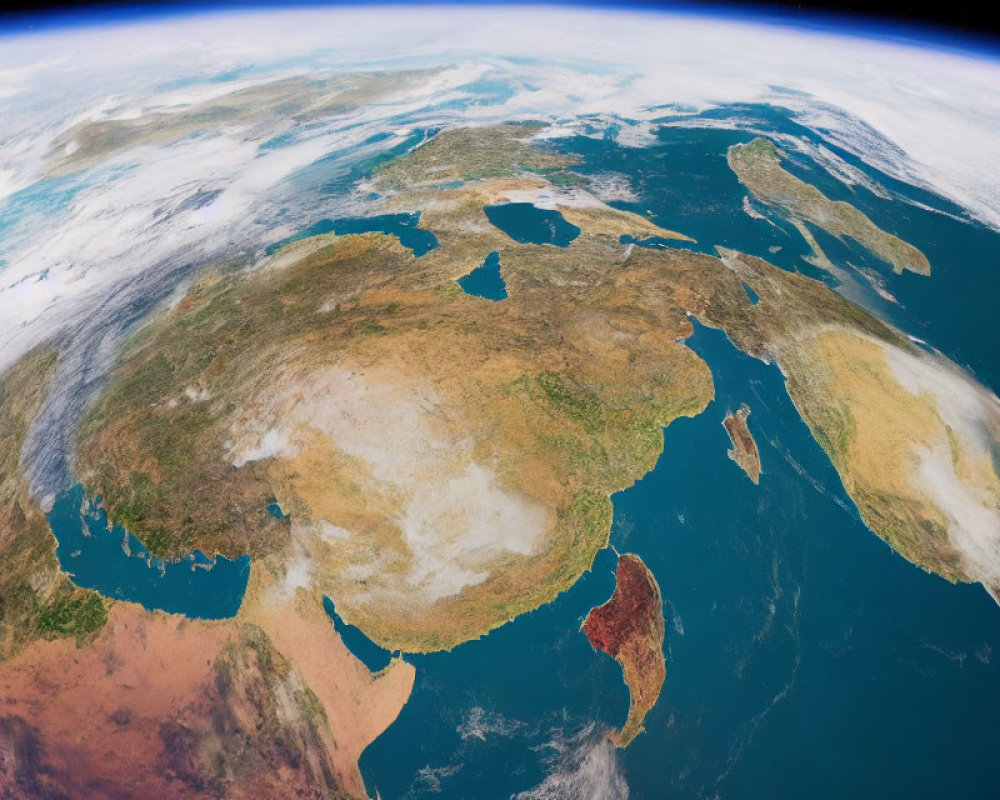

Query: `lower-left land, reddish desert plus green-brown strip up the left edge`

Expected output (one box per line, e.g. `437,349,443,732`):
0,350,415,800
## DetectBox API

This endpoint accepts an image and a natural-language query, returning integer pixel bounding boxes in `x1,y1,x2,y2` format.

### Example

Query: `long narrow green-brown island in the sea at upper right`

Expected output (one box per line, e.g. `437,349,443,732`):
728,138,931,275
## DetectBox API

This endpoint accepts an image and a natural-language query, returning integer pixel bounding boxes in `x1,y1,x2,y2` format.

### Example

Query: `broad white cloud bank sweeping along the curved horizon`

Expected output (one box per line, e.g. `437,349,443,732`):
0,6,1000,500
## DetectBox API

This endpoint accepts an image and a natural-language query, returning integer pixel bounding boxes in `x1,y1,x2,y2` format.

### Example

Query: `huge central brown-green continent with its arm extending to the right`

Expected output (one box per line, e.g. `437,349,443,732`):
66,114,995,652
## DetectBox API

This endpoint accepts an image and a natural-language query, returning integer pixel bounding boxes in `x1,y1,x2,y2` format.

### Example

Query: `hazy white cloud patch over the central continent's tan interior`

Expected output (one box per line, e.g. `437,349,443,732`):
230,367,551,604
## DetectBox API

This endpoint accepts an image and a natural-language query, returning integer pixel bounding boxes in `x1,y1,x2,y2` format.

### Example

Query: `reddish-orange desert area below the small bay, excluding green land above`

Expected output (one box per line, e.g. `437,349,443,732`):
0,592,412,800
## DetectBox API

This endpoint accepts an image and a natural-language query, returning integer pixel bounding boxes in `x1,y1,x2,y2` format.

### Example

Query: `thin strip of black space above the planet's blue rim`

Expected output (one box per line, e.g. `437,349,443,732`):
0,0,1000,47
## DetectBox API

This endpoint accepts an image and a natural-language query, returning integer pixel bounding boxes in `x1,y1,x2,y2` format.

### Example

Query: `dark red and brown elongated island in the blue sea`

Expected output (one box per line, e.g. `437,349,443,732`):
583,553,667,747
